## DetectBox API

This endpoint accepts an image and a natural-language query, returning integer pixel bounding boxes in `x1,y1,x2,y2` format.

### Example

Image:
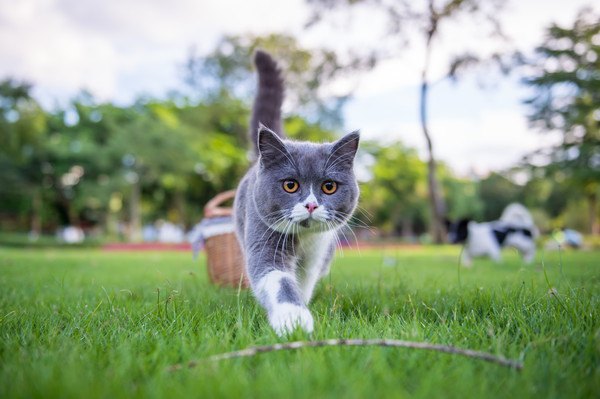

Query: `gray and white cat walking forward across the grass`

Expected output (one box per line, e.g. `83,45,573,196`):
234,51,359,335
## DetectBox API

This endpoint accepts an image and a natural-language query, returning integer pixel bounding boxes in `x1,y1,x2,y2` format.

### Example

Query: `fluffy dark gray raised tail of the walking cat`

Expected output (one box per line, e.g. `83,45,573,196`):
249,50,284,154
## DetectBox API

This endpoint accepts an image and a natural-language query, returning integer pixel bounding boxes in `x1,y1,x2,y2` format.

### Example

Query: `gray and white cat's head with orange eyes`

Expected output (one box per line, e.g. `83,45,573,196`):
253,126,359,233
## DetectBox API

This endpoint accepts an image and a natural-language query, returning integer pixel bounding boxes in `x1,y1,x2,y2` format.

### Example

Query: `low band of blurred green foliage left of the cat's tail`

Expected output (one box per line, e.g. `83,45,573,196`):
0,81,253,231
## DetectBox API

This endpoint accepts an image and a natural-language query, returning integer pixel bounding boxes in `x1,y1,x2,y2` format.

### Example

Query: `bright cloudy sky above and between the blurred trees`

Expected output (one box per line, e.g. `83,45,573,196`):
0,0,598,176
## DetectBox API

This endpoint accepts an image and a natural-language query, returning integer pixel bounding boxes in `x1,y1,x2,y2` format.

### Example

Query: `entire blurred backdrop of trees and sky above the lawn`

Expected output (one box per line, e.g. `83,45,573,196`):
0,0,600,245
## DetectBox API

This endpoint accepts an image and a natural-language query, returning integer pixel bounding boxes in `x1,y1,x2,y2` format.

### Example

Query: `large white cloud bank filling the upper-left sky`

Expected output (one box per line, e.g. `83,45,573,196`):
0,0,305,102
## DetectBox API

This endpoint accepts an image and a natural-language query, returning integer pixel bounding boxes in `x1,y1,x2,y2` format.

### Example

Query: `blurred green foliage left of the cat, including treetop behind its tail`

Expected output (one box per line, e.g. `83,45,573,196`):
0,35,356,238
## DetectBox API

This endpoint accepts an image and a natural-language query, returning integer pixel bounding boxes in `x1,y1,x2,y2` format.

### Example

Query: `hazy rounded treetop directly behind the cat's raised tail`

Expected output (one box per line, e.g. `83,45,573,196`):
184,34,366,129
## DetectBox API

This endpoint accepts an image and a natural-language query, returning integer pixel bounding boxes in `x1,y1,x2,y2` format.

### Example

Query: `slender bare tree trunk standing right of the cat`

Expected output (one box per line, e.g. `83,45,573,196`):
420,30,446,244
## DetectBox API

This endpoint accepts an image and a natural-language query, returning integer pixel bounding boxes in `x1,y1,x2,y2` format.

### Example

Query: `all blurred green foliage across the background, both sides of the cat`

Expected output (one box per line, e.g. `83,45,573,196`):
0,22,600,238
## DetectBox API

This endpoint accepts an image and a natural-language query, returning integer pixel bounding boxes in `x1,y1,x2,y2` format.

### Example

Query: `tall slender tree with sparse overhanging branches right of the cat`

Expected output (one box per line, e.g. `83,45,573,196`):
307,0,505,243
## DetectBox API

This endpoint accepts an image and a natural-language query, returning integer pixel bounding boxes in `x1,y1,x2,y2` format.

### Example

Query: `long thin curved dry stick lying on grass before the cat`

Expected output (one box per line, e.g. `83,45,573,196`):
169,339,523,371
